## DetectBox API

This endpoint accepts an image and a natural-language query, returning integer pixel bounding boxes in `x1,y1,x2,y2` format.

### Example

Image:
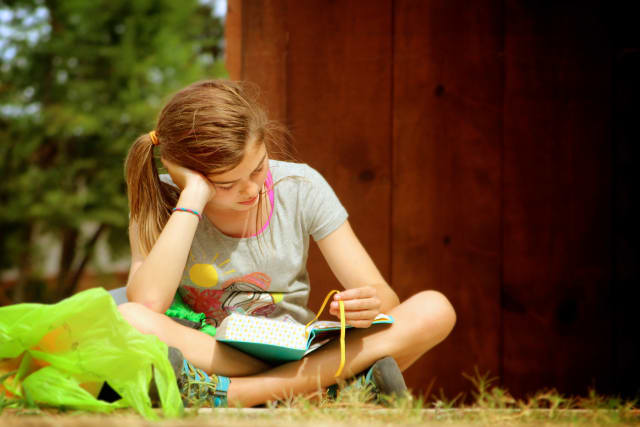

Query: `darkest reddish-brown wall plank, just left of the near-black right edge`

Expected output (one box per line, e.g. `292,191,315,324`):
503,0,613,400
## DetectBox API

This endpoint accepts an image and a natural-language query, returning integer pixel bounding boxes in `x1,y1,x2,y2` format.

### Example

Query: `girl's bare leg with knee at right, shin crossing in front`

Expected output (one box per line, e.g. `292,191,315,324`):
227,291,456,406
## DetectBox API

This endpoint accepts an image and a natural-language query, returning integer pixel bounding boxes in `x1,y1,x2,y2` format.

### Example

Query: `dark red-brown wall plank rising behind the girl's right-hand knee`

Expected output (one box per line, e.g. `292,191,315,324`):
392,0,503,398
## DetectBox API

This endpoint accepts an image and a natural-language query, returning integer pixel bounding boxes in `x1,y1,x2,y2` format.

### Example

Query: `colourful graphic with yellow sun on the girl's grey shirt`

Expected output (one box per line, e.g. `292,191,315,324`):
180,249,283,326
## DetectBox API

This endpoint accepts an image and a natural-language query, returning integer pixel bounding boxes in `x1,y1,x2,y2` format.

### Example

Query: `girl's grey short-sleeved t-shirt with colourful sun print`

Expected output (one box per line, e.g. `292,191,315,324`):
161,160,347,326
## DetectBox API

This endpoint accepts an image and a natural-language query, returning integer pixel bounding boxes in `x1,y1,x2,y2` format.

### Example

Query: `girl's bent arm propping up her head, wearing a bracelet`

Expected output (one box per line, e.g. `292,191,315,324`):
127,161,215,313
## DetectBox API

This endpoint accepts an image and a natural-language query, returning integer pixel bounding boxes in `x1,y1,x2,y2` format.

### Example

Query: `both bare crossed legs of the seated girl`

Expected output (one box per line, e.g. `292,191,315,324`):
119,291,456,406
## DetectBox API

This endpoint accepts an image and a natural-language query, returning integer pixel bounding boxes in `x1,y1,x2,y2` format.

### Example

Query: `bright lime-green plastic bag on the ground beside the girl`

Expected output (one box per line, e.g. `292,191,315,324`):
0,288,184,419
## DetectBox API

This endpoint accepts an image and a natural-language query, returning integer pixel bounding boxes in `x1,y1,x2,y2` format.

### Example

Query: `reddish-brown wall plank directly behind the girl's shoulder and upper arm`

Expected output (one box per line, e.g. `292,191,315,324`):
287,0,391,332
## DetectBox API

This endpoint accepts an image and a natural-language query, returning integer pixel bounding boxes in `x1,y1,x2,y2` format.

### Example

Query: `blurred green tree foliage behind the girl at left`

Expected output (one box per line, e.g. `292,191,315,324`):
0,0,224,300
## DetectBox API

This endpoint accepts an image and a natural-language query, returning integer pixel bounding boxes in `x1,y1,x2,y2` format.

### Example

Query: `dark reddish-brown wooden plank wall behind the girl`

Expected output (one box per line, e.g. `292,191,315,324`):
227,0,640,397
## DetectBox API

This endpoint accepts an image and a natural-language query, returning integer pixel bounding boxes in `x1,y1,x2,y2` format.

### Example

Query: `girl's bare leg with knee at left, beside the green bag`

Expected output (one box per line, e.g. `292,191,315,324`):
118,302,270,376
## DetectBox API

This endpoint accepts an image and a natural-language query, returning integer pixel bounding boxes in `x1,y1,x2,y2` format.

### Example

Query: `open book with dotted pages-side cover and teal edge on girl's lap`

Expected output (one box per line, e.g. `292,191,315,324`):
215,313,393,363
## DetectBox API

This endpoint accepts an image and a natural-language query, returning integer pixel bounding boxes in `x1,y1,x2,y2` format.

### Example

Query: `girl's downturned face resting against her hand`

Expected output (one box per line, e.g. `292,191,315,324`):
206,142,269,212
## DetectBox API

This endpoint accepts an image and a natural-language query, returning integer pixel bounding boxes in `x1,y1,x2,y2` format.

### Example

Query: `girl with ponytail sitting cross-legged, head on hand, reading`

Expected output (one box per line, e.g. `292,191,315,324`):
119,81,456,406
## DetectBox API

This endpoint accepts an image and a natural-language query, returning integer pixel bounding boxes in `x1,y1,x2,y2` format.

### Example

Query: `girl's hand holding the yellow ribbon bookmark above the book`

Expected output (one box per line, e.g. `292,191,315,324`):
329,286,380,328
